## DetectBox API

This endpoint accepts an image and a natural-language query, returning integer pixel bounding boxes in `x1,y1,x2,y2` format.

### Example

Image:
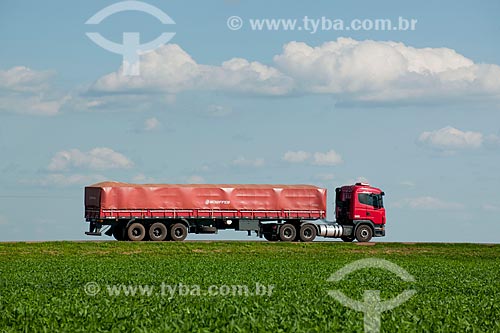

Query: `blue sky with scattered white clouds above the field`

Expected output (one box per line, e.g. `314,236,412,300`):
0,0,500,242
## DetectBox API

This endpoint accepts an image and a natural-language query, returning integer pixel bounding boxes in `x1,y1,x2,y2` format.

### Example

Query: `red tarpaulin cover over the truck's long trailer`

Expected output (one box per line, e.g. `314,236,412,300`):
85,182,326,211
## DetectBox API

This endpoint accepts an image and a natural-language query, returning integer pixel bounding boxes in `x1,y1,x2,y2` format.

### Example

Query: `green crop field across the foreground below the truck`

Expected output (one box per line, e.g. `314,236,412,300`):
0,241,500,332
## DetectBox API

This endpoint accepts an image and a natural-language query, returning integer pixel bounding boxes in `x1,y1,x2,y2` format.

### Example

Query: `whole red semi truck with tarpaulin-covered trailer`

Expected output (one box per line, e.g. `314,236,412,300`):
85,182,386,242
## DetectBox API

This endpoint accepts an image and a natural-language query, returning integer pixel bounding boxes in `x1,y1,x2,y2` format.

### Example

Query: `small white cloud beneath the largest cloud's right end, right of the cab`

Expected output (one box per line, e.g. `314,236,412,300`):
418,126,484,150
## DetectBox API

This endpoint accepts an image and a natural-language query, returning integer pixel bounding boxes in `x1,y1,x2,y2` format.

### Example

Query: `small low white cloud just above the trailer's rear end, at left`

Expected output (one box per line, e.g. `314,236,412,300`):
48,147,133,171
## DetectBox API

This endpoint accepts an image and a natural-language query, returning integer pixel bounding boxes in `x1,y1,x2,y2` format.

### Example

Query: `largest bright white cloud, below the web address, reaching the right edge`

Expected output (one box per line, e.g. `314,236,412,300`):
274,38,500,103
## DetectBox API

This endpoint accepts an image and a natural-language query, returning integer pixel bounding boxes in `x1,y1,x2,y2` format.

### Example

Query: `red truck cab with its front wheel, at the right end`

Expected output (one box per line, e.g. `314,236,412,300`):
335,183,386,241
